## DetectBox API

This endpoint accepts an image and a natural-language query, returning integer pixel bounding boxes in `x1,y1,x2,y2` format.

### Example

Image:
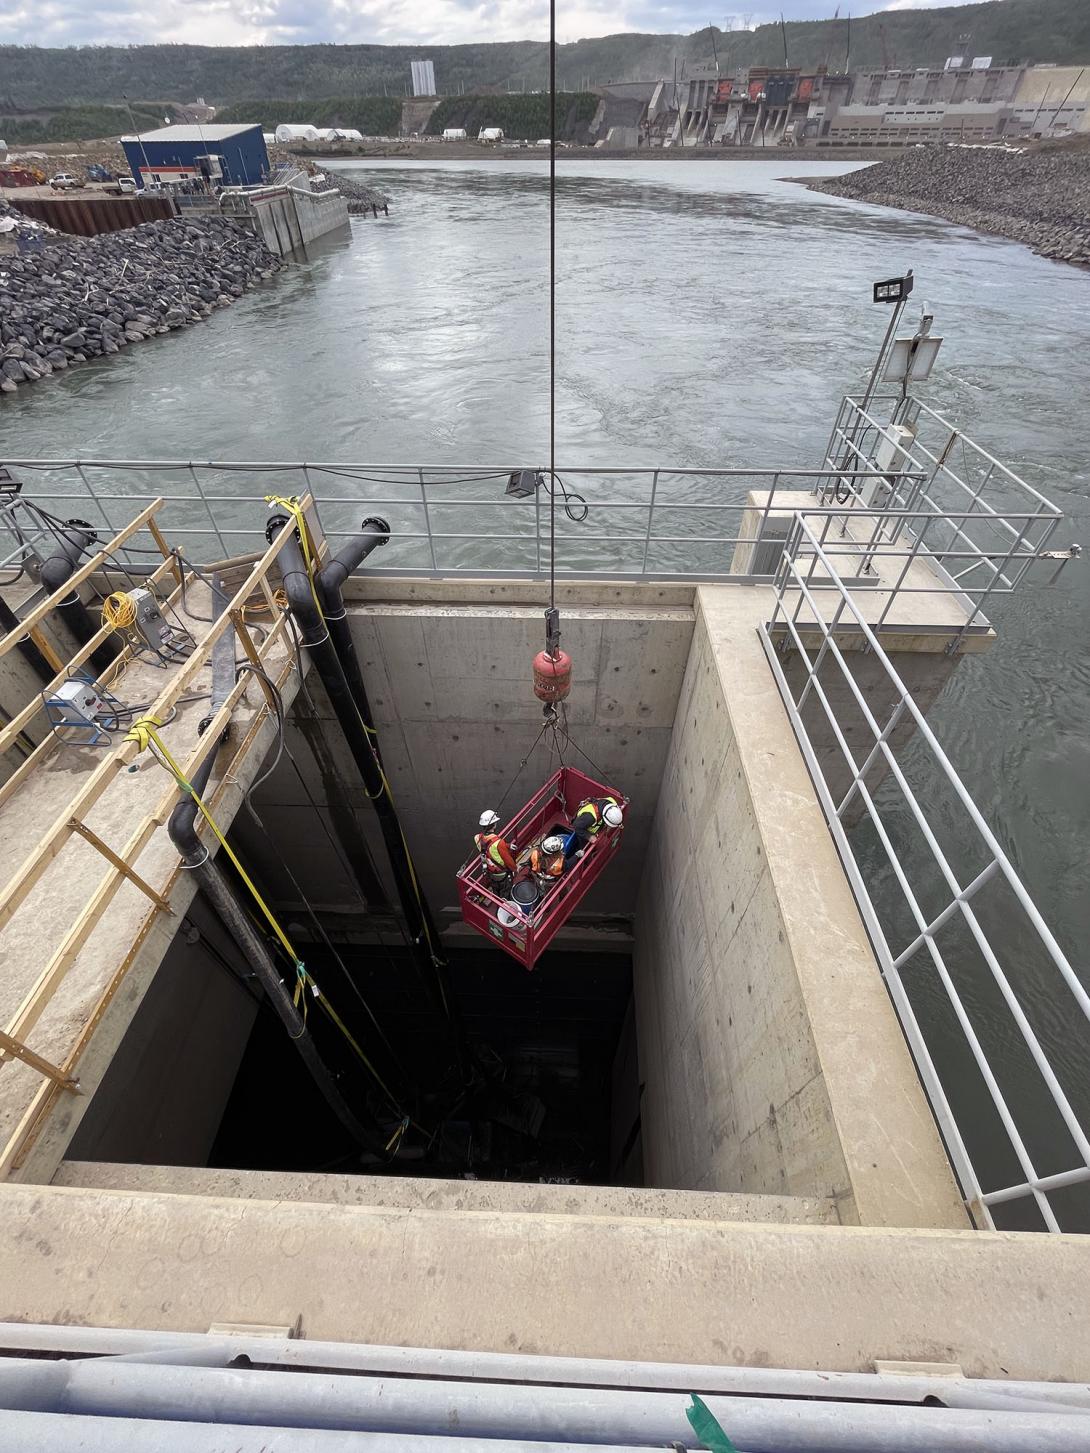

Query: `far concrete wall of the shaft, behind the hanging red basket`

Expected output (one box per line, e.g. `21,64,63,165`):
251,583,693,918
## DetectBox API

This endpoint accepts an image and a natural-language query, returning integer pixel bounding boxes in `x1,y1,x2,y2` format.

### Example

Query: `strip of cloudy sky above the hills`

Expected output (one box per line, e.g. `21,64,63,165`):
0,0,994,49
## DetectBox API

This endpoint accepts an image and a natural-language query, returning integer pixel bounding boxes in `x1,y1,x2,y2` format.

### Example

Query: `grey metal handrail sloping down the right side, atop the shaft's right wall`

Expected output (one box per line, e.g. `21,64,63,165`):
760,516,1090,1231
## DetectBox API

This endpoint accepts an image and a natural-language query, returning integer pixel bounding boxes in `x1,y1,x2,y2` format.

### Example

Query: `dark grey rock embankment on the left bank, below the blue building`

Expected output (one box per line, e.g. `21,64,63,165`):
0,218,283,394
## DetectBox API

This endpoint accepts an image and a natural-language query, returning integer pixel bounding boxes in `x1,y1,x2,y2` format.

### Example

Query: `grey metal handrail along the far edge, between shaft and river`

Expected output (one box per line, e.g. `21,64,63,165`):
0,458,1058,613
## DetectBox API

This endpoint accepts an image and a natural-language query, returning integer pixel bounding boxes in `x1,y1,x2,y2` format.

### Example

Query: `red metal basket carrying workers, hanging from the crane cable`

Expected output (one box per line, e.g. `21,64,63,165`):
458,767,628,969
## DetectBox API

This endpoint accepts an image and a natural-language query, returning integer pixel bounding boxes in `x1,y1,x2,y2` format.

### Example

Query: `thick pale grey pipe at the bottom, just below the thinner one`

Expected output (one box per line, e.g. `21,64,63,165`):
0,1359,1090,1453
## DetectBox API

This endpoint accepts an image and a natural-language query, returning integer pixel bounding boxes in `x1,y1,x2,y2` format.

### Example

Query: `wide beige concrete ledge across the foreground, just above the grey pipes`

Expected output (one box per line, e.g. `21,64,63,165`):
0,1184,1090,1382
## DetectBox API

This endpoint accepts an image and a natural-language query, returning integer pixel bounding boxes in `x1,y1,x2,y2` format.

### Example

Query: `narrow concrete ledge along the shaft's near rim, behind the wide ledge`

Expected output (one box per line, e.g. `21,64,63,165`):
52,1161,837,1225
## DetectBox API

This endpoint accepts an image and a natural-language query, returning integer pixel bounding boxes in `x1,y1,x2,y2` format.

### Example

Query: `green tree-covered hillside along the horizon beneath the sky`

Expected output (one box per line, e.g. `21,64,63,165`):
0,0,1090,114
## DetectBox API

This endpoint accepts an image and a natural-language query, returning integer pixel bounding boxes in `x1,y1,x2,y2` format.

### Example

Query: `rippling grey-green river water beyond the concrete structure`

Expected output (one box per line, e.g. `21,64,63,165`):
0,155,1090,1229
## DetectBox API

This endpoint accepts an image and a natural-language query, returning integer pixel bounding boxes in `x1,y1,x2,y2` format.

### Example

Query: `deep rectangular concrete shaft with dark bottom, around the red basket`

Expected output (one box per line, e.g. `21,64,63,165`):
55,581,966,1226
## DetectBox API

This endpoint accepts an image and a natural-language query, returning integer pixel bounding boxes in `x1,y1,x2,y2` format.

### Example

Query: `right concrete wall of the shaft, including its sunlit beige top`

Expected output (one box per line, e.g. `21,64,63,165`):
634,587,966,1226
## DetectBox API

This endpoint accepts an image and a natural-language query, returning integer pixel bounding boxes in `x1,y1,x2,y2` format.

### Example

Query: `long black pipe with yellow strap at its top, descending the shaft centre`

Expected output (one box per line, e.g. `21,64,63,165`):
274,514,462,1061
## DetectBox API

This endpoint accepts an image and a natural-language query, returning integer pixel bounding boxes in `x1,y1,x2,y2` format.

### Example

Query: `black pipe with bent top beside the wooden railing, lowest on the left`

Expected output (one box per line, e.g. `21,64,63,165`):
167,751,385,1158
